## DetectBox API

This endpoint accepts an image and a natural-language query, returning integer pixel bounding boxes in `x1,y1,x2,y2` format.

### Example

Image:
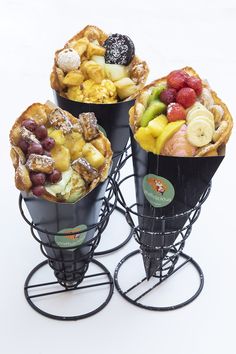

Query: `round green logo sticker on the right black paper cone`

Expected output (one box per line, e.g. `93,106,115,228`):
143,174,175,208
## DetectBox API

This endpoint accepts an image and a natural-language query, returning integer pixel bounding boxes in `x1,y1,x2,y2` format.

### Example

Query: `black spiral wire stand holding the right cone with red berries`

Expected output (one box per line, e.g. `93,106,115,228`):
114,175,211,311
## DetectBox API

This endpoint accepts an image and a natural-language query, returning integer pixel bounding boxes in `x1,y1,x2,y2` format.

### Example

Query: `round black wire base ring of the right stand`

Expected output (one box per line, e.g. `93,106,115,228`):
114,250,204,311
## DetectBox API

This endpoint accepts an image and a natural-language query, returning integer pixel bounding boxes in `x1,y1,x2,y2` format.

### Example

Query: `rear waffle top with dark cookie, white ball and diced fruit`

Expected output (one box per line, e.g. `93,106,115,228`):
51,27,146,103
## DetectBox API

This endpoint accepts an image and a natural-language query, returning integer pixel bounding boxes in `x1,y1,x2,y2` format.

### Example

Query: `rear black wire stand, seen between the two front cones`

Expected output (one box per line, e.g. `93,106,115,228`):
94,142,133,256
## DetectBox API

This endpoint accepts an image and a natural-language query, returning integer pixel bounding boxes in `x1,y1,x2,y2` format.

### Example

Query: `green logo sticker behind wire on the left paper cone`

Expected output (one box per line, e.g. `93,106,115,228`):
54,225,87,248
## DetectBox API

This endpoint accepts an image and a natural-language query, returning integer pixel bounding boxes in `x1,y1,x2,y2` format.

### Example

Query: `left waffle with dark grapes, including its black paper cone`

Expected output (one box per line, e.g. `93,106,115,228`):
10,102,112,285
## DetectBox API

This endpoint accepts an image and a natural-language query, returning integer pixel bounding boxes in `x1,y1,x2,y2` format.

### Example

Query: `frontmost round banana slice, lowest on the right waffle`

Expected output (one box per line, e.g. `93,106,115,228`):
187,117,214,147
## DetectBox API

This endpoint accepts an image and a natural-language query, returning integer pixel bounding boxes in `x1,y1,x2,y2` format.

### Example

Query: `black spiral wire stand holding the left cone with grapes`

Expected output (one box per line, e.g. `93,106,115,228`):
19,177,117,321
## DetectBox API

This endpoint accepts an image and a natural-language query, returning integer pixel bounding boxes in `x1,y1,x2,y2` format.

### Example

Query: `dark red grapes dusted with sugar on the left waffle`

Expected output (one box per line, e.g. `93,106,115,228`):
18,119,61,197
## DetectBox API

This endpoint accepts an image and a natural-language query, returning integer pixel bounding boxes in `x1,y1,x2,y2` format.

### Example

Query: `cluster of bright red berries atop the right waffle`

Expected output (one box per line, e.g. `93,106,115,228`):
160,70,202,122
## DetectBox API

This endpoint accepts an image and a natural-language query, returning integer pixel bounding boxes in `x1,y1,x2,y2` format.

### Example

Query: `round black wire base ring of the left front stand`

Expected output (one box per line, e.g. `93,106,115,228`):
24,259,114,321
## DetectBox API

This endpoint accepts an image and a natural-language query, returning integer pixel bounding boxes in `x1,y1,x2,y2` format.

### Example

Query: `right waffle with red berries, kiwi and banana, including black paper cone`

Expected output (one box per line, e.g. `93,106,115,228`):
130,67,233,277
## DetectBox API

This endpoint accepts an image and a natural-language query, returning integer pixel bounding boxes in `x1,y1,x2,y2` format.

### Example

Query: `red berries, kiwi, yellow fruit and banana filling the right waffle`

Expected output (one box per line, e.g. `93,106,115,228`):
135,70,218,156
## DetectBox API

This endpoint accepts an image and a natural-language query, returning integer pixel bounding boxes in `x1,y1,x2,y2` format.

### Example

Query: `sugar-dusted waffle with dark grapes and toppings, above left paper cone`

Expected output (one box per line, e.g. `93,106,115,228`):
10,103,112,202
